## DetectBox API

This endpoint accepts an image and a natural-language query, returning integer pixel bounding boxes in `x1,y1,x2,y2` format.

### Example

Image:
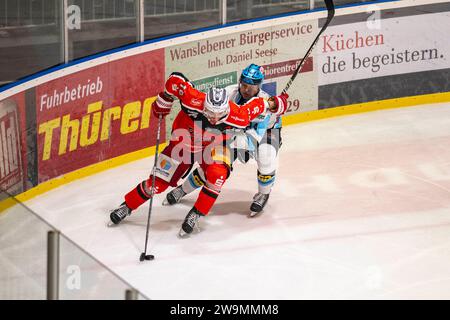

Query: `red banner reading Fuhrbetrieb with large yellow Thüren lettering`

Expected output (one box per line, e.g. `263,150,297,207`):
36,50,165,183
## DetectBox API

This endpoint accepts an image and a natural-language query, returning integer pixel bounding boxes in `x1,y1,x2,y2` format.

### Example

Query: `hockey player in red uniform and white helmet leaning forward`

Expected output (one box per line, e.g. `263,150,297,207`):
110,72,288,237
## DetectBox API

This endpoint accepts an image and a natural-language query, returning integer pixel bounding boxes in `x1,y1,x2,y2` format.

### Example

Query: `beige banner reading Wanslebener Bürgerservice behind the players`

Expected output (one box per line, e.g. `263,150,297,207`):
165,20,318,135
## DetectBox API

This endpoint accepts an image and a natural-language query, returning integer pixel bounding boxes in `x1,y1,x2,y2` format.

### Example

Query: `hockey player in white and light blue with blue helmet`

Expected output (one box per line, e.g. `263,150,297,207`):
164,64,281,217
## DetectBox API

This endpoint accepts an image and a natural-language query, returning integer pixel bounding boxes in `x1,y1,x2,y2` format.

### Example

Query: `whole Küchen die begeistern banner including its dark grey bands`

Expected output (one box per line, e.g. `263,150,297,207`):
317,3,450,109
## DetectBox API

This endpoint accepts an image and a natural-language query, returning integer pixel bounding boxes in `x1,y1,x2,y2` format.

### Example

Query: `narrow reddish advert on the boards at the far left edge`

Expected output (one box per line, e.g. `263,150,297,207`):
0,93,26,194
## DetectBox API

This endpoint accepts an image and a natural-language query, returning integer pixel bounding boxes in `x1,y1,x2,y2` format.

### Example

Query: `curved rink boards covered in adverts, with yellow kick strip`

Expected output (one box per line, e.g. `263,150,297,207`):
0,1,450,205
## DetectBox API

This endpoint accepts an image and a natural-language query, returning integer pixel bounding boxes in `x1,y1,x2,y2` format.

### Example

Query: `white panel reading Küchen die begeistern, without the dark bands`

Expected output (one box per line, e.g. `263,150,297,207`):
317,12,450,85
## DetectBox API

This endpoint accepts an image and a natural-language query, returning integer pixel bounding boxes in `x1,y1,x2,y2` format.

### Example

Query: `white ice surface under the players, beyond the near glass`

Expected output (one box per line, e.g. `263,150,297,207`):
22,104,450,299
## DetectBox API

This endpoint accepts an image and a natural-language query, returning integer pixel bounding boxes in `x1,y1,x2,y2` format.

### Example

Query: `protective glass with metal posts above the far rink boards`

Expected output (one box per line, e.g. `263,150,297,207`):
0,0,372,86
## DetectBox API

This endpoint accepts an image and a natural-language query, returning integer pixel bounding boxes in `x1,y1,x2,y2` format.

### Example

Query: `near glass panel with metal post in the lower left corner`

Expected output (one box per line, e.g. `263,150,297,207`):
0,191,148,300
